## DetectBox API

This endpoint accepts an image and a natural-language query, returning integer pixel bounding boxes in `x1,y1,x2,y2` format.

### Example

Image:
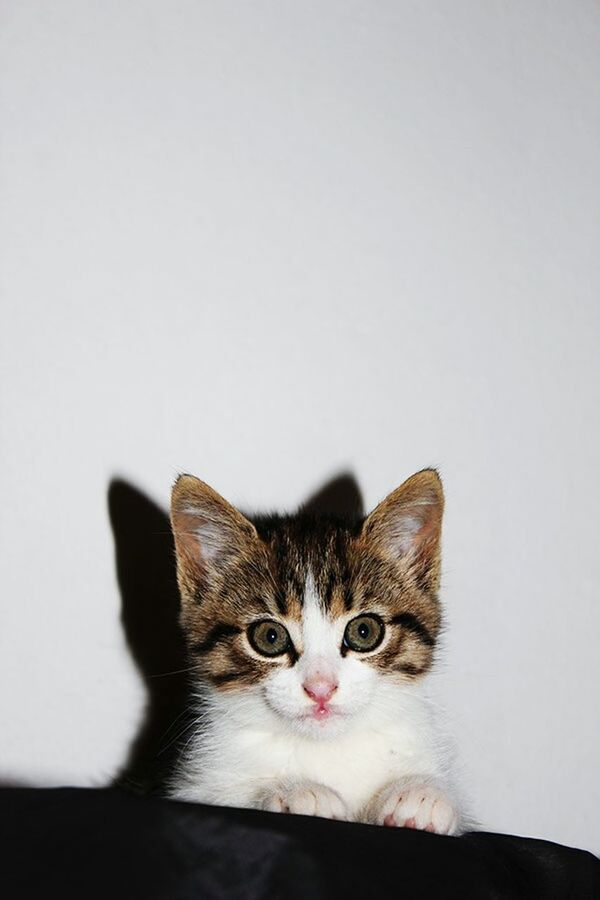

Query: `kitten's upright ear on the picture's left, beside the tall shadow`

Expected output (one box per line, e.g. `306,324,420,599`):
171,475,259,601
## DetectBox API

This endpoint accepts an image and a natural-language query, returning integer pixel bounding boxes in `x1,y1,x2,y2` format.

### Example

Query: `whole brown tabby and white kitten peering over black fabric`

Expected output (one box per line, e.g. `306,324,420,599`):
170,469,460,834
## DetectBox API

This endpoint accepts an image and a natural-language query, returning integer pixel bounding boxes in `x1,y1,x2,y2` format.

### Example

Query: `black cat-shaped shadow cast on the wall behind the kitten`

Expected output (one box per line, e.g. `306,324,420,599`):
108,473,364,793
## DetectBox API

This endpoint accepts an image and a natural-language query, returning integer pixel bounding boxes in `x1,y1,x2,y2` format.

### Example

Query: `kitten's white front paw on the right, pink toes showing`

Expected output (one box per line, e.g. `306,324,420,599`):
370,781,458,834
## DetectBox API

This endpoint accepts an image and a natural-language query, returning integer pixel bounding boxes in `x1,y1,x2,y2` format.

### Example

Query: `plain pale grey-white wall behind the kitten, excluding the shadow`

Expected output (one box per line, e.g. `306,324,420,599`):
0,0,600,850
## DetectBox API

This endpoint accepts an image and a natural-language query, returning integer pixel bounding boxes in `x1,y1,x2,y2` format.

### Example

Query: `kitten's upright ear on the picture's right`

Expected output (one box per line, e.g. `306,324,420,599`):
362,469,444,579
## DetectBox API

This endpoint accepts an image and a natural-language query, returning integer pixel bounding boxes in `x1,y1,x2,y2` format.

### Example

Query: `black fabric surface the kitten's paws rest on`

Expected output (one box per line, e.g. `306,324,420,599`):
0,788,600,900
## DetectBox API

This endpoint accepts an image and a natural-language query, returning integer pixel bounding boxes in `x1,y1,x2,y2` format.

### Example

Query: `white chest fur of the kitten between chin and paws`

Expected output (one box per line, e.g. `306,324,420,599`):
171,687,442,814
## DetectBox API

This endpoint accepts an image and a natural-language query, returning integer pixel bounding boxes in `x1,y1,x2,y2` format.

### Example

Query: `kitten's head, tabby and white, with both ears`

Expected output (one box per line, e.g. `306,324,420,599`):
171,469,444,736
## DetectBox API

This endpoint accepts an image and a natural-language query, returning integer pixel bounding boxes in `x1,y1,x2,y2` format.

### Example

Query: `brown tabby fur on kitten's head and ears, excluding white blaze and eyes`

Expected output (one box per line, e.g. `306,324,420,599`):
172,469,444,690
